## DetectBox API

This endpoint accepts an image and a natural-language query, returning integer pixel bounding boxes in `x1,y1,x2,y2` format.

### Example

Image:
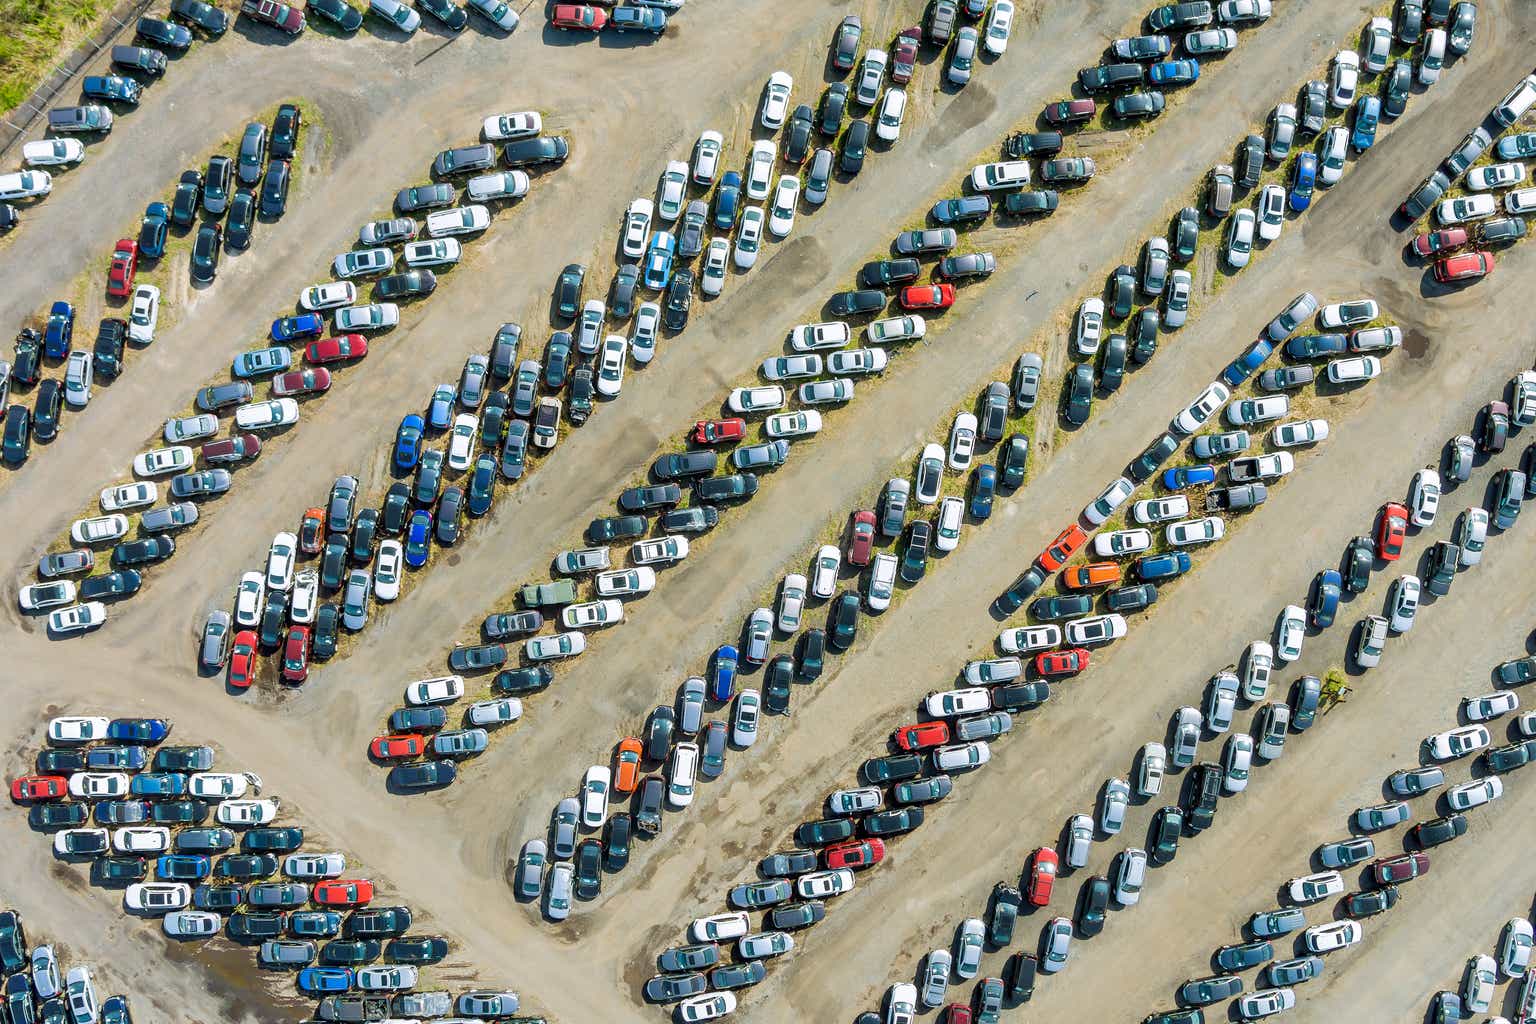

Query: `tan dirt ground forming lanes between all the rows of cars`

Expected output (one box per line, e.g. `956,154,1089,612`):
0,0,1536,1024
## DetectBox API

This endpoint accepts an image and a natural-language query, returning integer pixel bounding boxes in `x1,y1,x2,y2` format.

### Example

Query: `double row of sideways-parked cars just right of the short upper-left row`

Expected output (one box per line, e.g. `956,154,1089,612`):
20,115,552,635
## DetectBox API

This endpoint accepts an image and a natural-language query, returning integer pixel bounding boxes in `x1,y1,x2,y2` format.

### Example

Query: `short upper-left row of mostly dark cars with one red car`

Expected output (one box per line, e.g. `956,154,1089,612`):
0,103,303,465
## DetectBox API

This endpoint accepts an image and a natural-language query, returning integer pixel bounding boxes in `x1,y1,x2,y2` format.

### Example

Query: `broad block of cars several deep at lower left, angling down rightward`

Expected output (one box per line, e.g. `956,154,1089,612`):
9,715,531,1024
